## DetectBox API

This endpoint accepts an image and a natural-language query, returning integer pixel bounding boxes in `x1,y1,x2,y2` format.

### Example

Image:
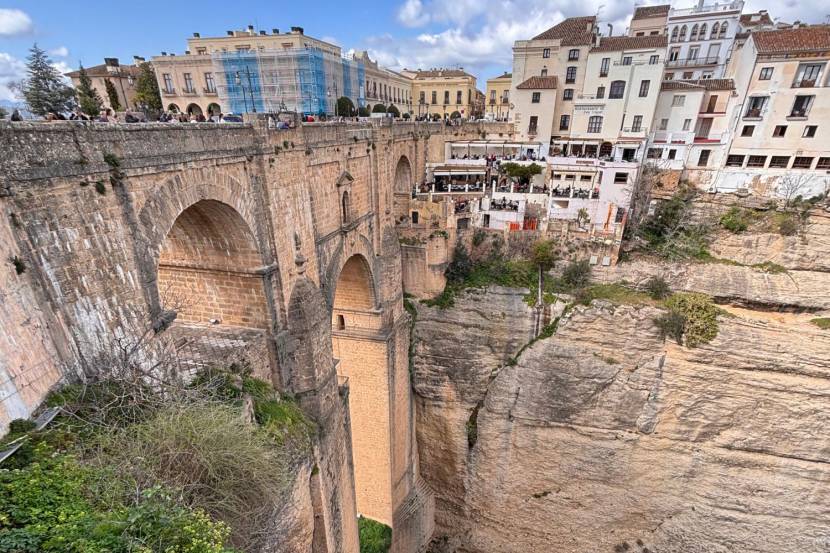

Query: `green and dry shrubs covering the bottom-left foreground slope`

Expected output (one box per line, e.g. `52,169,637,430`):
0,362,315,553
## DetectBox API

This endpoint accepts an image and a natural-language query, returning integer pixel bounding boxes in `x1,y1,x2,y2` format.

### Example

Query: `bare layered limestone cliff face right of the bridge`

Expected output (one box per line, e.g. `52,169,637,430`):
414,288,830,553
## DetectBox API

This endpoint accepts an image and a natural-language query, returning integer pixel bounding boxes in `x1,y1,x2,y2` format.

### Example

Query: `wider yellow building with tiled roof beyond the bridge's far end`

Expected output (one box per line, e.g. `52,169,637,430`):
401,69,477,119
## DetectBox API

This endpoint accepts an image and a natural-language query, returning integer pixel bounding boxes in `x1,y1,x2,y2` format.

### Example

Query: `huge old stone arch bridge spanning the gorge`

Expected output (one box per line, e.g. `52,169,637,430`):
0,122,510,552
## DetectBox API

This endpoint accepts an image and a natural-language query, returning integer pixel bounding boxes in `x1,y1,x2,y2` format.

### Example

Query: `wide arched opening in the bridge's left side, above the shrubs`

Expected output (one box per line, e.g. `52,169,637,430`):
157,200,271,379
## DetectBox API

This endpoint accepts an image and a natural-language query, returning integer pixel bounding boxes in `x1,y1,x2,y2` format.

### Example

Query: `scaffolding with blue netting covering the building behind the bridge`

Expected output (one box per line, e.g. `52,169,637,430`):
212,48,366,115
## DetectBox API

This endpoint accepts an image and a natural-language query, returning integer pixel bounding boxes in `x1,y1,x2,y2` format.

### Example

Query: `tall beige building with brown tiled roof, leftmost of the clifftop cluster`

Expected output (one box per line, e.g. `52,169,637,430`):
511,16,597,144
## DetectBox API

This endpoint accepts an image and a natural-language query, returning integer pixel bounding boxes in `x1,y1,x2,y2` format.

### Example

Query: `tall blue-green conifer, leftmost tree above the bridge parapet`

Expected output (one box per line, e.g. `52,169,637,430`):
14,44,75,117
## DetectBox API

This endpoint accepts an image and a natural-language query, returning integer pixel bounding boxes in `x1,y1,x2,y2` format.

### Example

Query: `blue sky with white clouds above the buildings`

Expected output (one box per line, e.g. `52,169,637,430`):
0,0,830,100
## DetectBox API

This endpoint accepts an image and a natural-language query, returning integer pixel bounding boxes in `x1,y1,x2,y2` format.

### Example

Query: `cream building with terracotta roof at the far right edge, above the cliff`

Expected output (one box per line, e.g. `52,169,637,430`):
711,25,830,197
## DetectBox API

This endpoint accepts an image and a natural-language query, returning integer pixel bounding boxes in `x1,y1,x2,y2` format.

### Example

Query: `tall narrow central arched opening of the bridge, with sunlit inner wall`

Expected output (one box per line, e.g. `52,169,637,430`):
331,254,393,526
